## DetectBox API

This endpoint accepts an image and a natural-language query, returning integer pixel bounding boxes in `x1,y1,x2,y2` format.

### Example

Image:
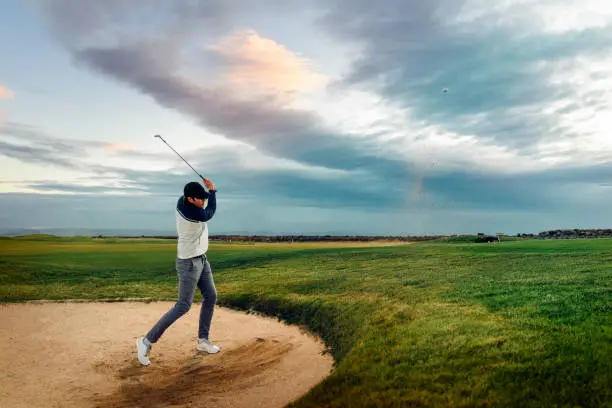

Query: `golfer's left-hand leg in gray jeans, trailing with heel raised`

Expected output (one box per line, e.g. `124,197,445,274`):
146,259,202,343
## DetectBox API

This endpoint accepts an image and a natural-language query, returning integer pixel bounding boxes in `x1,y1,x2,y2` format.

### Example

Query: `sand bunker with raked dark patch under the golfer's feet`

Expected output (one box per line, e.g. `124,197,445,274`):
0,302,333,408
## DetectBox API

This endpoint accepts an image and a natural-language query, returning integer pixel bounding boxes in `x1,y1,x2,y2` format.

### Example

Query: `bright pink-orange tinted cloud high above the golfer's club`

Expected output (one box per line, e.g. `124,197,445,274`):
208,30,327,98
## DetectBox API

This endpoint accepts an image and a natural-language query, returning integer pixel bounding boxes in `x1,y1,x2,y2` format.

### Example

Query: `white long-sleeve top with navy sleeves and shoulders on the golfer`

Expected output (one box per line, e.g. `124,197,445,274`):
176,191,217,259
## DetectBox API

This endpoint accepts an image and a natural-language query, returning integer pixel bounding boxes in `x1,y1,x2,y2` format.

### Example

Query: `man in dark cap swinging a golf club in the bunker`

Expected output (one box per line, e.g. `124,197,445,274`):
136,178,220,365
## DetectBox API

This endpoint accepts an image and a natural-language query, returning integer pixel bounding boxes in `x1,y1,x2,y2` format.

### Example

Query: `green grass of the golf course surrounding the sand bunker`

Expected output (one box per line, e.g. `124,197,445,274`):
0,237,612,407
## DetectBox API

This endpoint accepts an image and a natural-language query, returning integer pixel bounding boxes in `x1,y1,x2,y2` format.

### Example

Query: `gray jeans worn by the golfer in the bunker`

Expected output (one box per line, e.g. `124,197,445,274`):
147,256,217,343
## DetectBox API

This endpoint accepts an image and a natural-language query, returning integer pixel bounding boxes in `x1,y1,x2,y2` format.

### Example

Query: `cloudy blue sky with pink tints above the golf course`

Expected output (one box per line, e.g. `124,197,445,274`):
0,0,612,235
